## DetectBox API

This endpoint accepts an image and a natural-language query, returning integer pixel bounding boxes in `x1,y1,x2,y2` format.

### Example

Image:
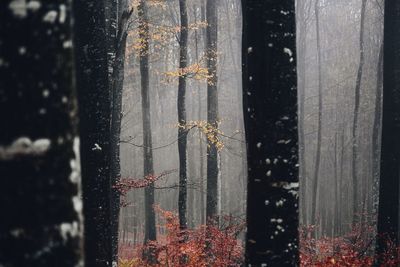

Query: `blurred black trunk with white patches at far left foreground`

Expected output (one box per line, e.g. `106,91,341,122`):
0,0,83,267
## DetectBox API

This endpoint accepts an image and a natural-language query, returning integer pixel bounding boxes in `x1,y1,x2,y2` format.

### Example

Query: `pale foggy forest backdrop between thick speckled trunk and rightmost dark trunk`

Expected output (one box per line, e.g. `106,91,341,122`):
297,0,383,238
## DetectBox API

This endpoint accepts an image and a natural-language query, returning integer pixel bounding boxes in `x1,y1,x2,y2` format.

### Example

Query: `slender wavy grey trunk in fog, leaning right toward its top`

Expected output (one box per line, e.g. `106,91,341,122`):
351,0,367,226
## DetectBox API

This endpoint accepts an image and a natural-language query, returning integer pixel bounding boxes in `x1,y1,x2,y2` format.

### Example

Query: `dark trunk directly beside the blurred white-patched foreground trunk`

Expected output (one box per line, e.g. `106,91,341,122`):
74,0,112,267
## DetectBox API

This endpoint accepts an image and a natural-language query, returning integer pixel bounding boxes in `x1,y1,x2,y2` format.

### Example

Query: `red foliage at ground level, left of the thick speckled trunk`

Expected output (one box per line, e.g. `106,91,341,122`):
119,208,244,267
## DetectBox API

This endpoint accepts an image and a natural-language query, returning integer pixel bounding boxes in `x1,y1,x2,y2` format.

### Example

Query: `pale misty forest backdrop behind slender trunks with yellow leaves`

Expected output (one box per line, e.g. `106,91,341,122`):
120,0,247,253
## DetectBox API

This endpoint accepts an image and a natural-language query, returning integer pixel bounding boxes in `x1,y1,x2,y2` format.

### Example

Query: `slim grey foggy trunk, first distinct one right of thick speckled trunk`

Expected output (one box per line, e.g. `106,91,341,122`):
311,0,323,229
